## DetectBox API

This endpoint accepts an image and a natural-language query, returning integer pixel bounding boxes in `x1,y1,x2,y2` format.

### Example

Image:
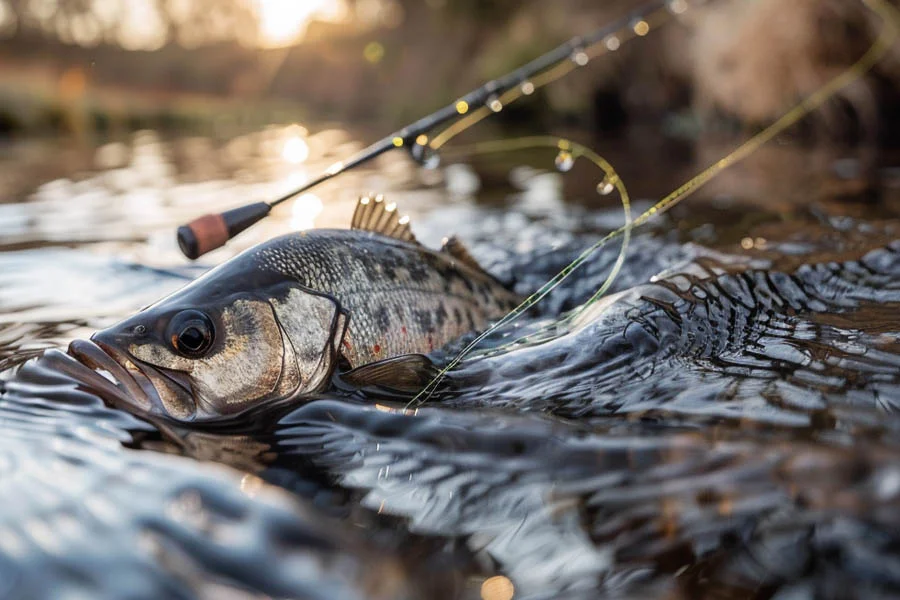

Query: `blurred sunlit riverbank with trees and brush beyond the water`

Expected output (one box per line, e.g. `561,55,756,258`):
0,0,897,137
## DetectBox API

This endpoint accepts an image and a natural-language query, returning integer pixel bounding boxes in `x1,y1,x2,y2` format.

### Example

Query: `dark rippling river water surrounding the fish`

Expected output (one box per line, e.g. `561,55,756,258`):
0,127,900,599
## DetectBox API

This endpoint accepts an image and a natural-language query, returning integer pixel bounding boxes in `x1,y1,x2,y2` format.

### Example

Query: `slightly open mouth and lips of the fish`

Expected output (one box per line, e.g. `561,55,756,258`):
68,340,195,416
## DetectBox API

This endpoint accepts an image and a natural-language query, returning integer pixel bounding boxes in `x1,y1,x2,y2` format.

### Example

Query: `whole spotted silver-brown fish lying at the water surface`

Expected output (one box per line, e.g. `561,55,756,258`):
69,195,520,421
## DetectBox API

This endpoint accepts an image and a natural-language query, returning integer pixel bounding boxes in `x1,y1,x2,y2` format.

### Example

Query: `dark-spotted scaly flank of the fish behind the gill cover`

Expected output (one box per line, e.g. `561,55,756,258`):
256,229,518,366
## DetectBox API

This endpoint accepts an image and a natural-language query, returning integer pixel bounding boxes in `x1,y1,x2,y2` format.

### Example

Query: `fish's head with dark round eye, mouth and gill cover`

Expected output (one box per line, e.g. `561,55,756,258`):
70,272,346,421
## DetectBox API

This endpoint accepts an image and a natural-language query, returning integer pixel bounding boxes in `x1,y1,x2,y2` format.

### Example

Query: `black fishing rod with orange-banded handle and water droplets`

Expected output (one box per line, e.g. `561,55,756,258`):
178,0,702,260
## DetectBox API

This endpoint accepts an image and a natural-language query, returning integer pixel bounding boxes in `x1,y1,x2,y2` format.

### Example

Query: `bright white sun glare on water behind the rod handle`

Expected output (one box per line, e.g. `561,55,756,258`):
0,126,426,258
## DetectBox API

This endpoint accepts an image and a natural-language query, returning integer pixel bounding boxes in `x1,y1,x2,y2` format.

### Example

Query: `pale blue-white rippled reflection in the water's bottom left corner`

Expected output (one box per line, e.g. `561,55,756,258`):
0,355,411,599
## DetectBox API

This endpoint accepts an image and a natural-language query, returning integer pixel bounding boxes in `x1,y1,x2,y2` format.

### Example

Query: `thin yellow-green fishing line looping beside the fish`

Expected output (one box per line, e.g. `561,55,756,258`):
407,0,900,407
